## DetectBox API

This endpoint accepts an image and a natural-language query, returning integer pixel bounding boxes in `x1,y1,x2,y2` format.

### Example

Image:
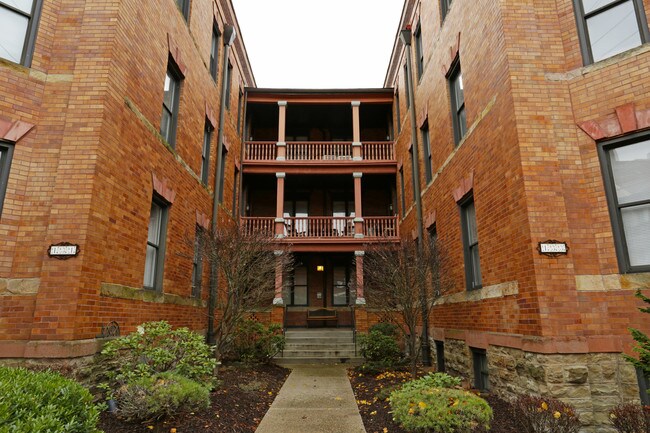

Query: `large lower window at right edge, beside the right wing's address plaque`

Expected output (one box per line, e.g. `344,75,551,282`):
599,133,650,272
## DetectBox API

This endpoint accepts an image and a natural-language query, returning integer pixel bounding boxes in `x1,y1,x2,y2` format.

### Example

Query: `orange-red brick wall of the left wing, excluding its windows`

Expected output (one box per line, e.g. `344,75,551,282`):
0,0,254,348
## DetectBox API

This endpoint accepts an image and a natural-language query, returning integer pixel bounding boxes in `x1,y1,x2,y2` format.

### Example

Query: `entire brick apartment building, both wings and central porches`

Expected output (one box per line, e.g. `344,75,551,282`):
0,0,650,431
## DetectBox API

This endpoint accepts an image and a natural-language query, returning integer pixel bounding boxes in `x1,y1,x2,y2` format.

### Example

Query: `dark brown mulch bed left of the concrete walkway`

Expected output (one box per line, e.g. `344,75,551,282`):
98,365,289,433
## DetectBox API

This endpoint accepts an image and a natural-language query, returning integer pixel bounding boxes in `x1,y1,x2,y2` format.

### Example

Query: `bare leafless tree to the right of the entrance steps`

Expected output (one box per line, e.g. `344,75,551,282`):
364,235,448,376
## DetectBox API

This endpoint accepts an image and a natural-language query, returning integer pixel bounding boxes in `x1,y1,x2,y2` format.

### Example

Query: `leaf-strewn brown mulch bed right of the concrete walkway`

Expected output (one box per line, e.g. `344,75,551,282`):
348,369,520,433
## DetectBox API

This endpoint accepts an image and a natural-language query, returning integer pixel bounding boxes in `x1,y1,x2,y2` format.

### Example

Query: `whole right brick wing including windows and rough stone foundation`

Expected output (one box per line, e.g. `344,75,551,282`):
385,0,650,431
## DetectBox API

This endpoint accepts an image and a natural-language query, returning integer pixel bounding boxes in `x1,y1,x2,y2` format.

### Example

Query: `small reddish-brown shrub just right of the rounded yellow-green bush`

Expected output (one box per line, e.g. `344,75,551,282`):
513,395,580,433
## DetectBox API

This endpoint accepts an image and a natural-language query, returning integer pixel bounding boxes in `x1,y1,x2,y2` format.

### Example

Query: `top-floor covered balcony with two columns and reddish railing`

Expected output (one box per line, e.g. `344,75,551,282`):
243,89,397,174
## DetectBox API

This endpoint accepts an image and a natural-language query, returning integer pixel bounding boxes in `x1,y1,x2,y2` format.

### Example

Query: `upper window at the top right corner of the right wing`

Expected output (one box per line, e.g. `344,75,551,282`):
574,0,649,65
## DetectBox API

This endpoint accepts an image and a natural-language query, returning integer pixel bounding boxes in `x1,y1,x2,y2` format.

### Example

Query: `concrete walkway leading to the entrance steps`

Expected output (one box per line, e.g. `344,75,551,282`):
256,365,366,433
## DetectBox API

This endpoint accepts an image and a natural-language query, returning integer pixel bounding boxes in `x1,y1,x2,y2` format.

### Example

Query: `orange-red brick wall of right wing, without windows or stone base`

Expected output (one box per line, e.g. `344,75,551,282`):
388,0,650,350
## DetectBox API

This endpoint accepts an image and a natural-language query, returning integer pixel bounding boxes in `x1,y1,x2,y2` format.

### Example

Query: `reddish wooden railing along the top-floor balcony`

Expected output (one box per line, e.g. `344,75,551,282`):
244,141,395,161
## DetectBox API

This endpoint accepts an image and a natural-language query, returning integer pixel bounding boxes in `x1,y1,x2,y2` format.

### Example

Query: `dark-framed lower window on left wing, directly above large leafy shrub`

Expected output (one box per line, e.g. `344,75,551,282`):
144,196,169,291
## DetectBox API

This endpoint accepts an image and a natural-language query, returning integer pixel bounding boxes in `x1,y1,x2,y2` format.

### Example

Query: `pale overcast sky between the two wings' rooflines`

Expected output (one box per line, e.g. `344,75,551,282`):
232,0,404,89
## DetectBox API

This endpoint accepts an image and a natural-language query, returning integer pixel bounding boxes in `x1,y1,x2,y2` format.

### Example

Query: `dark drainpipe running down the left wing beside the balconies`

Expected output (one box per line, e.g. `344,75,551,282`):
207,24,237,345
